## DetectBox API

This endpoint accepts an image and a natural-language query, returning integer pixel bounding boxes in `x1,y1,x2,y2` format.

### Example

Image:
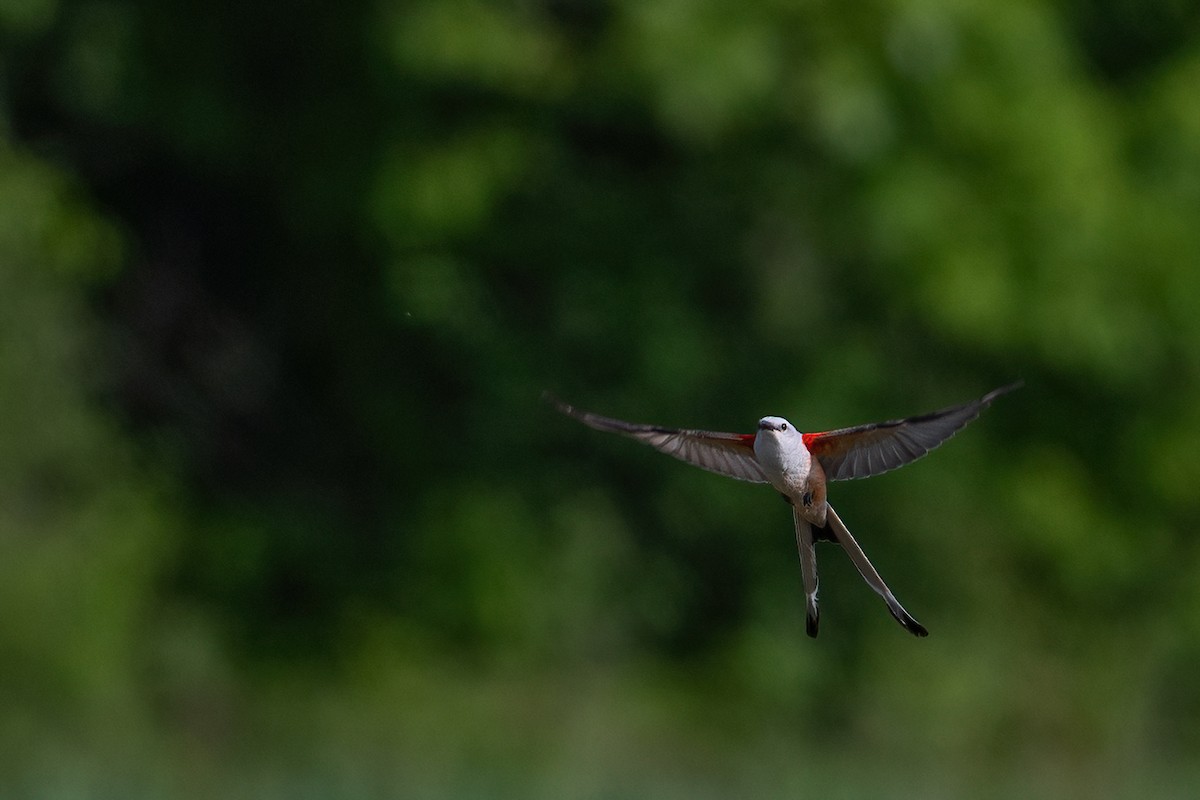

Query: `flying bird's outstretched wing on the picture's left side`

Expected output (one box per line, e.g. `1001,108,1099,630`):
546,395,767,483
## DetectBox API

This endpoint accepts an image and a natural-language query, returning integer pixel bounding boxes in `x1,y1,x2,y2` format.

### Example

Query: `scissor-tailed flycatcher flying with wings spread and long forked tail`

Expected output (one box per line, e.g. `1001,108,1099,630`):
545,381,1022,638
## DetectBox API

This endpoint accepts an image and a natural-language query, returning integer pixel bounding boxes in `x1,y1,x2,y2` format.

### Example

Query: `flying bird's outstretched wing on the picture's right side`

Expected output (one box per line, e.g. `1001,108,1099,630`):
804,383,1021,481
